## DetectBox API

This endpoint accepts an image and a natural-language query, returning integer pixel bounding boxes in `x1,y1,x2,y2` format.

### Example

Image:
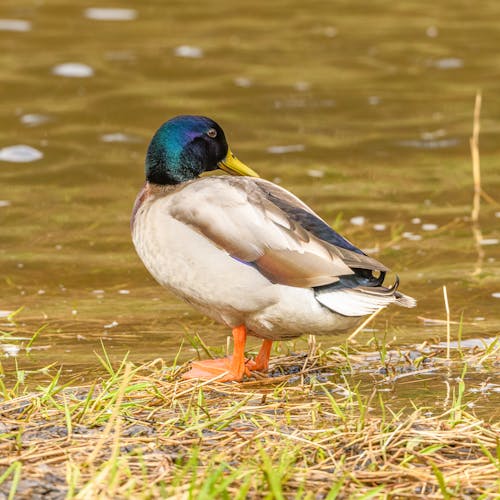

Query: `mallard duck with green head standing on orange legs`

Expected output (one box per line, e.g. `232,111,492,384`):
131,116,415,381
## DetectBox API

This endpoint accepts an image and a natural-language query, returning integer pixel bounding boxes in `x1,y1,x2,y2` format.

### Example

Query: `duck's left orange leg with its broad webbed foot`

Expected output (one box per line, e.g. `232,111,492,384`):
183,325,247,382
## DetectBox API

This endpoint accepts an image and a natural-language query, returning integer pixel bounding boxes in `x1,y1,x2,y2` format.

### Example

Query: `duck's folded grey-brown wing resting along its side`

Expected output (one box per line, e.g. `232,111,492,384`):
169,176,387,287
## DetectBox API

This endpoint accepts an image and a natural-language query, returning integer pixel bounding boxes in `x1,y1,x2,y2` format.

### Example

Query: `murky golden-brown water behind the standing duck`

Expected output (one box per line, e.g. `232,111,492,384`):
0,0,500,406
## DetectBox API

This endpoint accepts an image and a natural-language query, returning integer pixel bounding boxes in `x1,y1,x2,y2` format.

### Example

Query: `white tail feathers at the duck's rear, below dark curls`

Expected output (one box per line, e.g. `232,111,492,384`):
315,288,417,316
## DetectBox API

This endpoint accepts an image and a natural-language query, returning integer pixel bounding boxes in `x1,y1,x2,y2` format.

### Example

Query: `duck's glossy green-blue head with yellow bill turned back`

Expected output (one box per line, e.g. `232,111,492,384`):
146,115,258,184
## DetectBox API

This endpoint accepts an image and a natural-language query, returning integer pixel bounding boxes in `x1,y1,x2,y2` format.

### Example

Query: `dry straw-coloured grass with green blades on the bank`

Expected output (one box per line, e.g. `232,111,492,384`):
0,340,500,499
